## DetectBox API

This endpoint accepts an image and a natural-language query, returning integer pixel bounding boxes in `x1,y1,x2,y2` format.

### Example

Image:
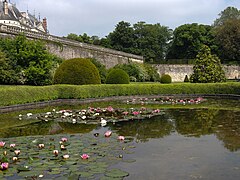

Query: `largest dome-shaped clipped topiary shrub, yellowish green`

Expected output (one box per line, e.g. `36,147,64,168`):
53,58,101,85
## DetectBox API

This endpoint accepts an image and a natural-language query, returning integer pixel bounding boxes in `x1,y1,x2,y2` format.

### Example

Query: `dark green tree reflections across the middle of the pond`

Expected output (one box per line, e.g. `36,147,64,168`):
0,109,240,151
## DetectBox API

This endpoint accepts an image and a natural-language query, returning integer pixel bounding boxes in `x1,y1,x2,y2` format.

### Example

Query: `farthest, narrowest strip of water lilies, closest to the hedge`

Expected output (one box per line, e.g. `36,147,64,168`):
126,97,206,105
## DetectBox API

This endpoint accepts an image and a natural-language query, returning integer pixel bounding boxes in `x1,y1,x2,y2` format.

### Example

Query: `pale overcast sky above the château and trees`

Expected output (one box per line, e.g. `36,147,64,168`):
11,0,240,37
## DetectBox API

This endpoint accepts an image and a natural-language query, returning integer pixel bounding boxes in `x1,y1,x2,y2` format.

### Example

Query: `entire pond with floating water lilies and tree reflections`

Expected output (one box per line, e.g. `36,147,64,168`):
0,97,240,179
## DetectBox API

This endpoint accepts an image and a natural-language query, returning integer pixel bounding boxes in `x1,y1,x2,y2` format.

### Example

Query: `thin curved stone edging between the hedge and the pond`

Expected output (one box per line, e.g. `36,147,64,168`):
0,94,240,114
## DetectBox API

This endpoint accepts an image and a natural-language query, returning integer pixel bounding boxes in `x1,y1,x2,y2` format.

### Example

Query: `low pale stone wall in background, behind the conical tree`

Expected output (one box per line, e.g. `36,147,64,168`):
155,64,240,82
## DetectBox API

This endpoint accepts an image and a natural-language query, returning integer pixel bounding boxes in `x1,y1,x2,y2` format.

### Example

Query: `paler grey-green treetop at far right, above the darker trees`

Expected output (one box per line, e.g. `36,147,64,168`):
214,7,240,26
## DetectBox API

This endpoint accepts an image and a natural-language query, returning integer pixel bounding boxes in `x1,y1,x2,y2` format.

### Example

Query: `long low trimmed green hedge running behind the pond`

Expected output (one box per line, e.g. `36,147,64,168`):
0,82,240,106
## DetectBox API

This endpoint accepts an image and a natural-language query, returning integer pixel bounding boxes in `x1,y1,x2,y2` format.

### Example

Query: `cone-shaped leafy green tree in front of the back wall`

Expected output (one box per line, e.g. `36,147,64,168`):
190,46,226,83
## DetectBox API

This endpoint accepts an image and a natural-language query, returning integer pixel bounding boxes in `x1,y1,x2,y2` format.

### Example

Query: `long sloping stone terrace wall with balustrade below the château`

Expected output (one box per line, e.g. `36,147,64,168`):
0,24,143,68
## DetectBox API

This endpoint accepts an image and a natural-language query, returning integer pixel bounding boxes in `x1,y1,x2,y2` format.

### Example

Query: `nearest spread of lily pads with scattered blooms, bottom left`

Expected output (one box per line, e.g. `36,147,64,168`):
0,130,130,179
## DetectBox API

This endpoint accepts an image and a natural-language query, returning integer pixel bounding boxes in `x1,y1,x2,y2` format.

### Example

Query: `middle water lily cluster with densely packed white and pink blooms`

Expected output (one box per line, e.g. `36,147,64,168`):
19,106,164,126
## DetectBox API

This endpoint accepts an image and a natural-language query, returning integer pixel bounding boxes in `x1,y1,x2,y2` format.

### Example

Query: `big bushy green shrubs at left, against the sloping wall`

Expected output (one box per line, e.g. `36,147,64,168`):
0,35,61,85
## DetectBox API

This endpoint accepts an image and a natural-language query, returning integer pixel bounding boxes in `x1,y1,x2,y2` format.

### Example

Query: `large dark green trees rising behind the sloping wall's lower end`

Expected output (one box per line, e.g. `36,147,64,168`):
104,21,172,62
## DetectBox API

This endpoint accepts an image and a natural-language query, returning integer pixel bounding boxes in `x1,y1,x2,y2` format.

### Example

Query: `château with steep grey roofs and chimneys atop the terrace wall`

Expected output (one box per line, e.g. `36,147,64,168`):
0,0,48,33
